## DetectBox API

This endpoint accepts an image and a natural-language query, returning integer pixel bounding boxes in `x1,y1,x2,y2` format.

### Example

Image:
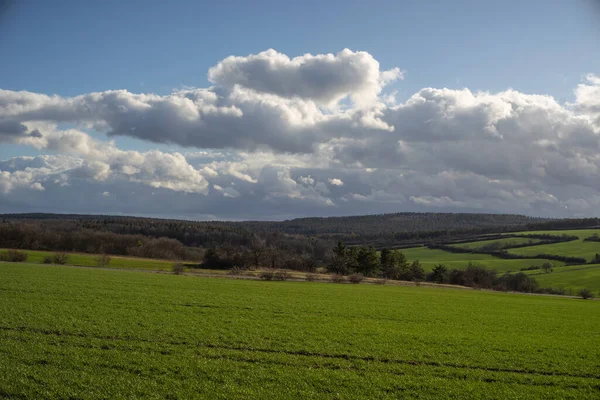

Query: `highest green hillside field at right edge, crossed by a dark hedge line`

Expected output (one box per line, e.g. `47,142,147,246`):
508,229,600,261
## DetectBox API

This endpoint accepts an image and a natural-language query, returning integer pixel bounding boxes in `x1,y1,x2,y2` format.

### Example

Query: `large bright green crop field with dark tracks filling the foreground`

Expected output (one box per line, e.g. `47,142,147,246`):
0,263,600,399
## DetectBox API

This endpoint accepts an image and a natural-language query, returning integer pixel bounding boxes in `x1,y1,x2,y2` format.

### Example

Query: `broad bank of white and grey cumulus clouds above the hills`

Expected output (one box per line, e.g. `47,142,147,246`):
0,50,600,219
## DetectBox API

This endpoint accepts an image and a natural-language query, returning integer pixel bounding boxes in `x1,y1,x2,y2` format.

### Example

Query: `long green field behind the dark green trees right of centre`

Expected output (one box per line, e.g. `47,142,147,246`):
400,246,564,273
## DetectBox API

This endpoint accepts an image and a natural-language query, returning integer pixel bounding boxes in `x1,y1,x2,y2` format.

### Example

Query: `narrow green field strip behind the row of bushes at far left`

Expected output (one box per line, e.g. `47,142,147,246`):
0,249,175,271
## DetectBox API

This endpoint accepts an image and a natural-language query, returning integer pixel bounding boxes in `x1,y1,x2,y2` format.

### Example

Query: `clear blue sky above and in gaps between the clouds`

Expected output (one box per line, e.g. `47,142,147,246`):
0,0,600,219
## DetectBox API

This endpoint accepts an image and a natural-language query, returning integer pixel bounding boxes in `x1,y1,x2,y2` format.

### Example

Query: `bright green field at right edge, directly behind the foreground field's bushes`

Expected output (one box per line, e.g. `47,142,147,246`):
528,264,600,296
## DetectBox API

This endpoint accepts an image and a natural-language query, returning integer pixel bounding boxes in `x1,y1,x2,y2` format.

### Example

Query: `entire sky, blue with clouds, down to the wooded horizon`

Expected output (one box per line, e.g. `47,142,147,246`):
0,0,600,220
